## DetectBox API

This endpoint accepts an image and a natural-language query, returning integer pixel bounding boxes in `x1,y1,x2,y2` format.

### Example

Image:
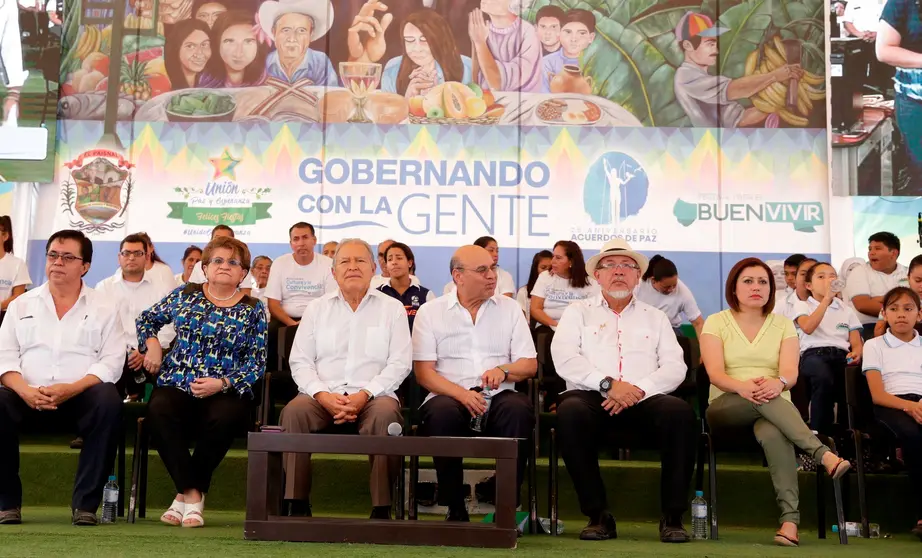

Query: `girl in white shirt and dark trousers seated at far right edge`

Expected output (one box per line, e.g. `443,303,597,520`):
862,287,922,539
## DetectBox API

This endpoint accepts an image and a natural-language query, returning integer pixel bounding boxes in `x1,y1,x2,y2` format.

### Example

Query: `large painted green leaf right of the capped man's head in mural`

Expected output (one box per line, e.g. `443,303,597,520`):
717,0,772,78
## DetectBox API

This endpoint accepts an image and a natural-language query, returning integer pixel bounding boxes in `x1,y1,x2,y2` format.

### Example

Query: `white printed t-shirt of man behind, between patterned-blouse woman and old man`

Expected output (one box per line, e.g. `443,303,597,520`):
265,254,339,320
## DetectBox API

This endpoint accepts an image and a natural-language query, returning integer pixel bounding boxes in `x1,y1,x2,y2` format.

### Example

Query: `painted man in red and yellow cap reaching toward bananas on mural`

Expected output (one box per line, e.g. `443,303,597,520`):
674,12,804,128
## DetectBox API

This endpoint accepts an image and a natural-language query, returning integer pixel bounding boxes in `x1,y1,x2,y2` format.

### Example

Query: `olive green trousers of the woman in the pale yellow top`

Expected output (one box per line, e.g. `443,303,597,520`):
707,393,829,525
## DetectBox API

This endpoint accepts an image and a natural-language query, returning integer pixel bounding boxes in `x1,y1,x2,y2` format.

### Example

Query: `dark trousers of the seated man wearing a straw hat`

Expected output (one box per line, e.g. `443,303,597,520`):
557,391,698,518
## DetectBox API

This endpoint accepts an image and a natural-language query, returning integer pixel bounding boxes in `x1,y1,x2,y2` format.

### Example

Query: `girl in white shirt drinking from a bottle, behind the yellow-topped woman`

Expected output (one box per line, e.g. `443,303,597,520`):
794,262,862,435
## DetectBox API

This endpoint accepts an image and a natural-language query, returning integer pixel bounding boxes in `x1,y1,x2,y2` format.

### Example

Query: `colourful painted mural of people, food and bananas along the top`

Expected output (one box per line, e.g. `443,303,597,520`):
61,0,826,133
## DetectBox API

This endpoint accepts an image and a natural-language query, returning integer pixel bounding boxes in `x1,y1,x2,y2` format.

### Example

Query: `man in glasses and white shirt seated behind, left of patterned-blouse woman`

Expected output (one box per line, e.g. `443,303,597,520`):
96,234,176,399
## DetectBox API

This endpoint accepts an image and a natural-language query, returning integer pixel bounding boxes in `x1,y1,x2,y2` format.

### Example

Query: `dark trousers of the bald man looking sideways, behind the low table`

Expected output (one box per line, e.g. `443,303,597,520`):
420,390,535,509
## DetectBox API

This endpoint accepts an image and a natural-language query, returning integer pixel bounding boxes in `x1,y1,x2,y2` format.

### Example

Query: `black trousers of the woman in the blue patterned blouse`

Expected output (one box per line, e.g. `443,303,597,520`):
146,387,250,493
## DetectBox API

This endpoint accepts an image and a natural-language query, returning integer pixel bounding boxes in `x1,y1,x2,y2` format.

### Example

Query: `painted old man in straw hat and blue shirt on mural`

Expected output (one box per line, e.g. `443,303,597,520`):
259,0,338,86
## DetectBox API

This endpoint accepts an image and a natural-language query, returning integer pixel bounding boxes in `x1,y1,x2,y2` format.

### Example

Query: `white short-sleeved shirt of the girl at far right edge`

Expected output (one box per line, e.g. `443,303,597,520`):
861,329,922,395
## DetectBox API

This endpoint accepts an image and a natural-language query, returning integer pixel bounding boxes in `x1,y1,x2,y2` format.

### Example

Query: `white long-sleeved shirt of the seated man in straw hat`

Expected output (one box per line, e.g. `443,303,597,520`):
551,294,687,399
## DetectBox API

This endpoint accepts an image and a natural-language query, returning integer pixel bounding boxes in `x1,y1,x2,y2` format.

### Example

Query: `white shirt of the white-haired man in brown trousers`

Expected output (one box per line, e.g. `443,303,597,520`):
289,288,413,399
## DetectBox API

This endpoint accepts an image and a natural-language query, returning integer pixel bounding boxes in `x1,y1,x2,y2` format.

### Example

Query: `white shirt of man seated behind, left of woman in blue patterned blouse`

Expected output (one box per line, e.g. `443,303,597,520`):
96,269,176,349
